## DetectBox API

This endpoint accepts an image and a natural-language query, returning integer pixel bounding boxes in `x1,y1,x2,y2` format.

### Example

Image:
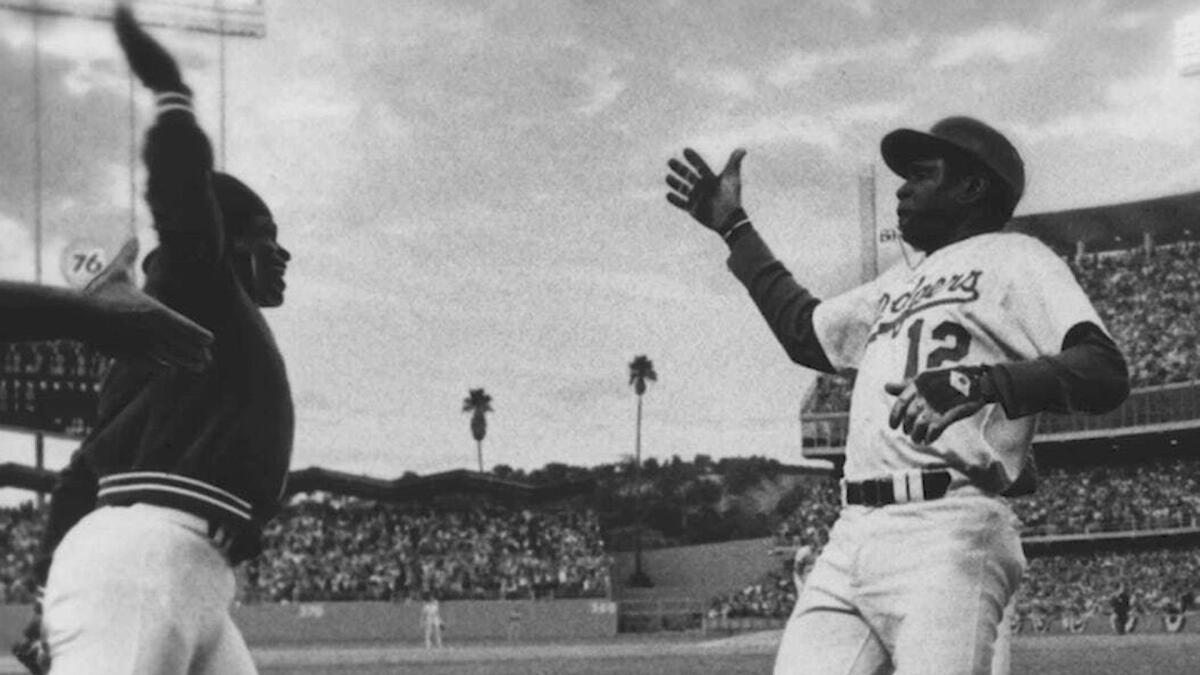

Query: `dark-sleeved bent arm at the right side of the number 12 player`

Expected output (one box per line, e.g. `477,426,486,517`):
989,323,1129,419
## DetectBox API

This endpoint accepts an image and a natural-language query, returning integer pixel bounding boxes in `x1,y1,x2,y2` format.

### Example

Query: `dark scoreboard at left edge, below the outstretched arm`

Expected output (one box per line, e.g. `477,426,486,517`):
0,340,113,438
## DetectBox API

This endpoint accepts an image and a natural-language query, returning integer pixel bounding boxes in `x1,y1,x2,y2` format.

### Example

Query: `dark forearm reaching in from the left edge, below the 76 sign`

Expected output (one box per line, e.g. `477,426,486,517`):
0,281,108,341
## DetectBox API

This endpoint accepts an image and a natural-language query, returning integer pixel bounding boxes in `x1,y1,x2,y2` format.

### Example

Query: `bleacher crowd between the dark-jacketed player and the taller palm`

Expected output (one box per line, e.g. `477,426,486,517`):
244,497,611,602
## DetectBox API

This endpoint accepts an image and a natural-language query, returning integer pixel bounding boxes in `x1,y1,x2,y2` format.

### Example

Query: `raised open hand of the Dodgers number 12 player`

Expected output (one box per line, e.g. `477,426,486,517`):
667,148,746,234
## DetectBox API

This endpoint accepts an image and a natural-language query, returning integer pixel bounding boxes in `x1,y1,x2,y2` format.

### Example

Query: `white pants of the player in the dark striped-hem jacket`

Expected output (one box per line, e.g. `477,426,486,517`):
42,504,257,675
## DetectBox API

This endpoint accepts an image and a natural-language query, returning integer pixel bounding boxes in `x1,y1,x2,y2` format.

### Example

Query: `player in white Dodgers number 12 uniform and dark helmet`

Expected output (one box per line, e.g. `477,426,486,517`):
667,117,1129,675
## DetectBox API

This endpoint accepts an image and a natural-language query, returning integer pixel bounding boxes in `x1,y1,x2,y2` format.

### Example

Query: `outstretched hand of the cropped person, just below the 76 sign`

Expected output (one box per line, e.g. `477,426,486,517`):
84,239,212,371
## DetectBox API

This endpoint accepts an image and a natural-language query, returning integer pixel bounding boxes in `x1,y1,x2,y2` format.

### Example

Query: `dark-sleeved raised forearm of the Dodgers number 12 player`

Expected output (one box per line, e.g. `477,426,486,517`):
726,223,834,372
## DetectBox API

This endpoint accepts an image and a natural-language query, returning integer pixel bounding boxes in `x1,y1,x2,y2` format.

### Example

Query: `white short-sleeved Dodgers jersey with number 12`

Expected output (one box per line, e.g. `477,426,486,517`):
812,232,1104,489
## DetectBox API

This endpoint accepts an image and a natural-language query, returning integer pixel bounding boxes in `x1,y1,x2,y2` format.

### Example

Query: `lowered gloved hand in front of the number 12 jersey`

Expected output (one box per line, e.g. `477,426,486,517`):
883,366,990,443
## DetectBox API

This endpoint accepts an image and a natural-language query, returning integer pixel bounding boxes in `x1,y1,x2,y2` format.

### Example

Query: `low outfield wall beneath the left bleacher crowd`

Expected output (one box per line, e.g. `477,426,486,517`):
0,599,617,649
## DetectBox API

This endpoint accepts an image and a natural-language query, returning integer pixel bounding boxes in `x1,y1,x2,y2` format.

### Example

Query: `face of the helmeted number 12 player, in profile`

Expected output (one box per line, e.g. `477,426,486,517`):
896,157,962,251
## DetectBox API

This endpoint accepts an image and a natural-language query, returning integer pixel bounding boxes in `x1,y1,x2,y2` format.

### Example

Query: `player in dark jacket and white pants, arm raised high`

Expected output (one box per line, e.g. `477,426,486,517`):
22,7,293,675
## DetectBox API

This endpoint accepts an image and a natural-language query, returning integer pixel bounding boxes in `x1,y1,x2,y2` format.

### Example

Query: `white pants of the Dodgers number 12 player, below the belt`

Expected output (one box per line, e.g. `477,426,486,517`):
775,495,1025,675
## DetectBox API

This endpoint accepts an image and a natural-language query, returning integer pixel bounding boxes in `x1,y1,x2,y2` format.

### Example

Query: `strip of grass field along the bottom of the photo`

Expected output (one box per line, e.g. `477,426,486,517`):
0,632,1200,675
